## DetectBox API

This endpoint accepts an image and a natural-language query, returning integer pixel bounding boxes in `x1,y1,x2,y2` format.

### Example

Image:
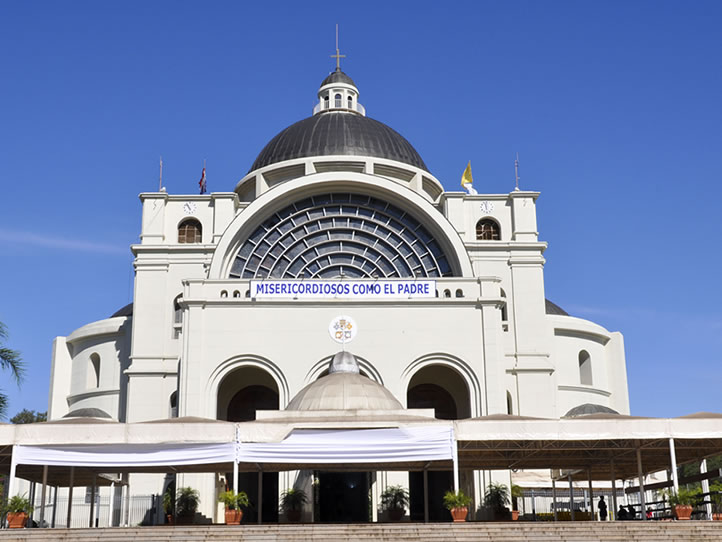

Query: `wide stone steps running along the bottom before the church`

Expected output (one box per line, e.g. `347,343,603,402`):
0,521,722,542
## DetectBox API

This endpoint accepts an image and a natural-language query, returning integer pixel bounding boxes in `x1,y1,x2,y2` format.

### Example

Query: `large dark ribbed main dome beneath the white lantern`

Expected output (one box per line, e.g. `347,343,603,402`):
249,113,428,171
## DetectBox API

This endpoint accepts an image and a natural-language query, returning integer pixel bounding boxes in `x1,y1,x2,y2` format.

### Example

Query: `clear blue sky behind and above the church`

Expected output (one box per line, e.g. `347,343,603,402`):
0,0,722,416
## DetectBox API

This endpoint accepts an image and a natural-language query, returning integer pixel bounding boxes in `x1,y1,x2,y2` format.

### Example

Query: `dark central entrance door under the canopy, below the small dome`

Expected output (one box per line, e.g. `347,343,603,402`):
318,472,369,523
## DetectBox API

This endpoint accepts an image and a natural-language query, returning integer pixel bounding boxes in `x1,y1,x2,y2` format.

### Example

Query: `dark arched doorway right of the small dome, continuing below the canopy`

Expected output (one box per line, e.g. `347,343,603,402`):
406,365,471,521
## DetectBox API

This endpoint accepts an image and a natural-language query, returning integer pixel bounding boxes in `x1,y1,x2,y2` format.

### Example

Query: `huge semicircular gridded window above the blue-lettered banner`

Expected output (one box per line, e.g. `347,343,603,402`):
230,193,453,279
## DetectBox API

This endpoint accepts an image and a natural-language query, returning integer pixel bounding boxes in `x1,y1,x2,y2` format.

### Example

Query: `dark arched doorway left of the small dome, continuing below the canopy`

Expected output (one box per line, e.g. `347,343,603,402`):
216,367,279,523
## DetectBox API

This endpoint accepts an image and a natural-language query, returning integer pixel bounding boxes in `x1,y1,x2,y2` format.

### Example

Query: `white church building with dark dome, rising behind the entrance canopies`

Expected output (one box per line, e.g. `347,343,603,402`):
49,65,629,519
